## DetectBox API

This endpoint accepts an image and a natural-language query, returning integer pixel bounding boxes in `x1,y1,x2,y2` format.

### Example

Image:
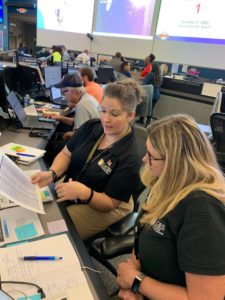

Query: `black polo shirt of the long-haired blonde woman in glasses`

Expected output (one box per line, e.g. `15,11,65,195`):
137,191,225,286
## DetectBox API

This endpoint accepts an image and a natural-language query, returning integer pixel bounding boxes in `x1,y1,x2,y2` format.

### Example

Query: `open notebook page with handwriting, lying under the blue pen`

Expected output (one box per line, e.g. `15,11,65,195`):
0,234,93,300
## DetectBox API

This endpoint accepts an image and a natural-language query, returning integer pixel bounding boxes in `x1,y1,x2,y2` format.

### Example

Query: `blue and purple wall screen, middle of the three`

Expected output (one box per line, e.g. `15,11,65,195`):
94,0,155,38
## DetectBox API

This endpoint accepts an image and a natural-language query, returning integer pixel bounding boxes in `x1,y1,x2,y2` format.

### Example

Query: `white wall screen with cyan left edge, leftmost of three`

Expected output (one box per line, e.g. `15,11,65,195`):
37,0,94,34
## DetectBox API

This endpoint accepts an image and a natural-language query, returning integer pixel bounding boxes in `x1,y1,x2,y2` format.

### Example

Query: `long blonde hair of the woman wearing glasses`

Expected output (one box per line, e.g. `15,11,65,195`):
141,115,225,225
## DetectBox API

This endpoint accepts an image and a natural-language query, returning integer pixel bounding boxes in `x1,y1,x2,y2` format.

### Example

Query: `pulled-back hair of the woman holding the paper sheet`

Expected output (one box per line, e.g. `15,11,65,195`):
103,79,144,113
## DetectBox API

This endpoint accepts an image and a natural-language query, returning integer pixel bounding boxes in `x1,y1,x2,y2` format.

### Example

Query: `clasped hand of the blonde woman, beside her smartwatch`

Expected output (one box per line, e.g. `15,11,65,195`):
116,259,140,289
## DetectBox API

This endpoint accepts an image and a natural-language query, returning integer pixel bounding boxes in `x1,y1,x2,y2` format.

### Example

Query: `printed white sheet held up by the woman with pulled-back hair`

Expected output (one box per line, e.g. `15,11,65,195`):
0,154,45,214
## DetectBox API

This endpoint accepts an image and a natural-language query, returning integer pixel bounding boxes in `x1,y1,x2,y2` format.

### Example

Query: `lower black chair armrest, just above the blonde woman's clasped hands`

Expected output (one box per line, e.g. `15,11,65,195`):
100,235,134,259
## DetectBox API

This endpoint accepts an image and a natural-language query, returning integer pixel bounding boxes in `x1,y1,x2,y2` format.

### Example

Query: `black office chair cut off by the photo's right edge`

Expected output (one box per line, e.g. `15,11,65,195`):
210,113,225,170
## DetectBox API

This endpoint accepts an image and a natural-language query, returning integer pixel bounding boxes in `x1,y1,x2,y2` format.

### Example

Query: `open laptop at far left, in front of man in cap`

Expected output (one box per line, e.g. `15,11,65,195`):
7,91,54,130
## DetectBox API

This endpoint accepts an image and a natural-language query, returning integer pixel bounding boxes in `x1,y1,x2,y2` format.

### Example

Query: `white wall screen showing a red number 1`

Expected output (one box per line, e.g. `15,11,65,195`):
156,0,225,44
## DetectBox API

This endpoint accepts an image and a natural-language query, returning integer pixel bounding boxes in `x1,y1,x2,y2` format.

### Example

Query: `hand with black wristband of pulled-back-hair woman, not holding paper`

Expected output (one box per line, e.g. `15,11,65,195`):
56,179,91,202
